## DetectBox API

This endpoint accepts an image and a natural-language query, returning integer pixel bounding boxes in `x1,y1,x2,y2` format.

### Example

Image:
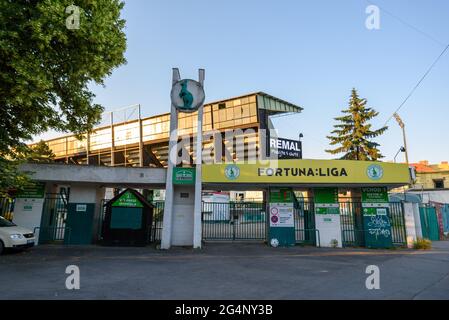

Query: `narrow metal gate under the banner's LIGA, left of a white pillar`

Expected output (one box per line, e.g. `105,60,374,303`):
294,199,319,245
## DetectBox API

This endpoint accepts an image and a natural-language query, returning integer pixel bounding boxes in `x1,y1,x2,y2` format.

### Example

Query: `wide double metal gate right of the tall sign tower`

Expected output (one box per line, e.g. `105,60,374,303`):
202,202,267,241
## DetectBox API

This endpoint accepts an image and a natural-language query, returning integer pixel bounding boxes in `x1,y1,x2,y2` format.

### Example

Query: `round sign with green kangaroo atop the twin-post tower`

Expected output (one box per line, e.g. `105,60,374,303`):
170,79,205,112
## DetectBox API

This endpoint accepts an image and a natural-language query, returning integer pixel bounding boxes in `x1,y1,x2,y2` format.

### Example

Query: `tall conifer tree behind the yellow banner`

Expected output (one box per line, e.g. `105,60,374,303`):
326,89,388,161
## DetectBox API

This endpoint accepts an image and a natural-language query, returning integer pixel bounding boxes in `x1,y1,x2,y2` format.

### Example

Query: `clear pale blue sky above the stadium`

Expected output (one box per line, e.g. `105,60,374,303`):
36,0,449,163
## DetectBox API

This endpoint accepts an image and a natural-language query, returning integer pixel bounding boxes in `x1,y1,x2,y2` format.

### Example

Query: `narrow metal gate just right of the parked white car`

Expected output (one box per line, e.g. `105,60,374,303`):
35,193,70,244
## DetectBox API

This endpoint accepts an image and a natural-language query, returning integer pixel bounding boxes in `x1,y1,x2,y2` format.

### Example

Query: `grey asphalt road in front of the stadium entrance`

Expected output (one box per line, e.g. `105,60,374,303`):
0,242,449,299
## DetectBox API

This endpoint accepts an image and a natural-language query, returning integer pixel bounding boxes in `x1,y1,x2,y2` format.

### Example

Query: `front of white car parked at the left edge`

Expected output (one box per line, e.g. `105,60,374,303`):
0,216,36,254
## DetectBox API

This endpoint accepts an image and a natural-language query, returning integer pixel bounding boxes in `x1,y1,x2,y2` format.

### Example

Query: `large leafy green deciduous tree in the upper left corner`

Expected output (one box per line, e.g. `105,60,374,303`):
0,0,126,195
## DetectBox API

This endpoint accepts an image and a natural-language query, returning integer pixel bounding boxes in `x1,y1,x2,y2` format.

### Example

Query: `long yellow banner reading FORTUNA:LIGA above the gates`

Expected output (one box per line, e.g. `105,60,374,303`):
202,160,410,185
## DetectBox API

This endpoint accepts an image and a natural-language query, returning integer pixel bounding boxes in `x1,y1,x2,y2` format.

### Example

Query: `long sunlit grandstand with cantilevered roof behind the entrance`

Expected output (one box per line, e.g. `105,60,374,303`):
38,92,303,167
